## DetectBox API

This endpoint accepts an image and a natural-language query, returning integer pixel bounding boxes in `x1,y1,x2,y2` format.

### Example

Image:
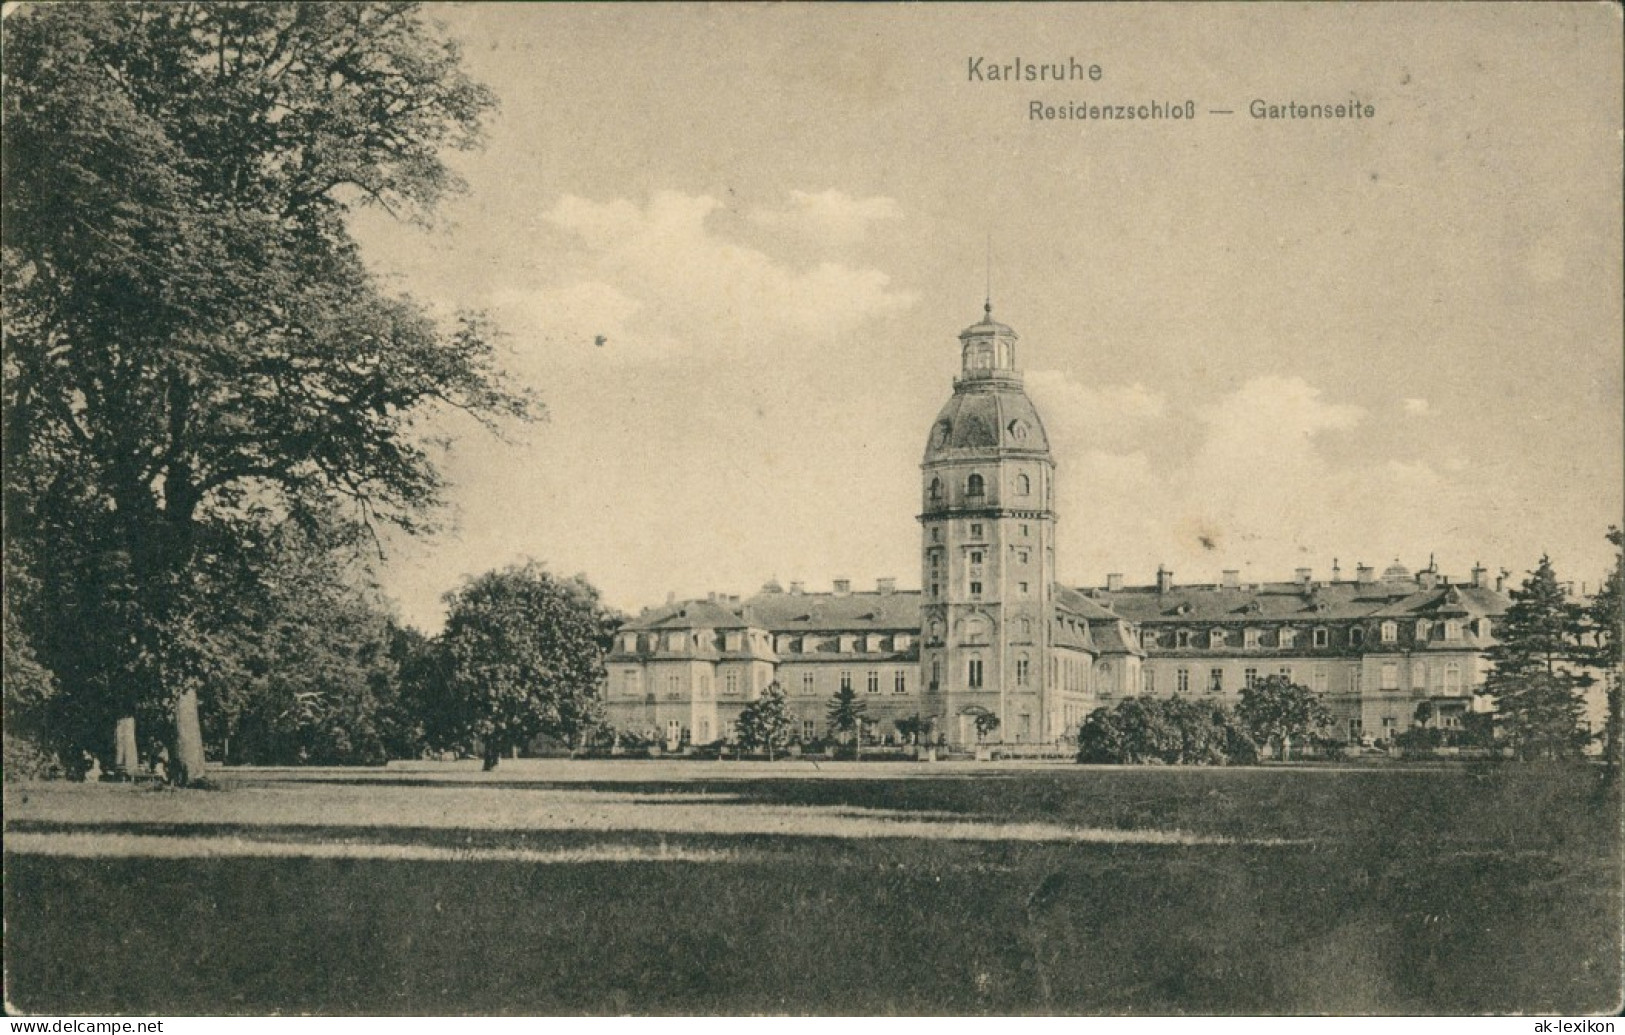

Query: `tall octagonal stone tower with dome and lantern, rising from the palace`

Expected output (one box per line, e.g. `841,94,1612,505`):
920,302,1060,744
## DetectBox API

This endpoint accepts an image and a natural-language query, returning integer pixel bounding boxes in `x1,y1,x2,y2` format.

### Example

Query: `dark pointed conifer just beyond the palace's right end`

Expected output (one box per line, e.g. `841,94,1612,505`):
1484,557,1591,759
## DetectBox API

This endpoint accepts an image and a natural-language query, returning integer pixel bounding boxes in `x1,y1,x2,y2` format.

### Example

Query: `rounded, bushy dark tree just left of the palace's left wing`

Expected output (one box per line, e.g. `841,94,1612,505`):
416,562,619,769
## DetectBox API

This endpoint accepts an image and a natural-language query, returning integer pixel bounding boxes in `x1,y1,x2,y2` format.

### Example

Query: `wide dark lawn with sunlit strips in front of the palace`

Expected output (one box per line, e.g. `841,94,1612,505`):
5,762,1622,1016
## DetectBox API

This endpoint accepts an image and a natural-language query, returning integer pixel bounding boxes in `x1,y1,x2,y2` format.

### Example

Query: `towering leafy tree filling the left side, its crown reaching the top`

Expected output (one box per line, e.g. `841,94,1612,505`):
0,3,531,782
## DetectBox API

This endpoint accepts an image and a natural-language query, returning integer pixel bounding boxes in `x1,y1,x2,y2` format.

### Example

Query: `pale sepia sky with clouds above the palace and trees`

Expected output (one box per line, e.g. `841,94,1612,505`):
358,3,1625,629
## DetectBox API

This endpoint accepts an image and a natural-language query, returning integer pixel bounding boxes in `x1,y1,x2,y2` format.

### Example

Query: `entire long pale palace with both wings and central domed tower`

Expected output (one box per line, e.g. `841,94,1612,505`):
605,305,1510,746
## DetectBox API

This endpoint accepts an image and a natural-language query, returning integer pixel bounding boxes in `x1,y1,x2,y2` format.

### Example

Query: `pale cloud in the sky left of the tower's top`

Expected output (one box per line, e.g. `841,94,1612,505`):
492,190,913,357
